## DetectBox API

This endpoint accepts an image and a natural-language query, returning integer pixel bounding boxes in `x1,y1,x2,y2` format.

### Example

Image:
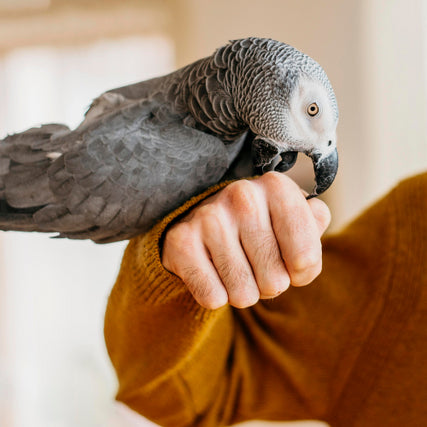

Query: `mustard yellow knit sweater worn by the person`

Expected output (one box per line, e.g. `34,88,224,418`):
105,174,427,427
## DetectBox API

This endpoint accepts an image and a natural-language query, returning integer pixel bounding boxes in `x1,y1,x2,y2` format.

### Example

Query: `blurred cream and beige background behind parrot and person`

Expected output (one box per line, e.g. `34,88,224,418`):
0,0,427,427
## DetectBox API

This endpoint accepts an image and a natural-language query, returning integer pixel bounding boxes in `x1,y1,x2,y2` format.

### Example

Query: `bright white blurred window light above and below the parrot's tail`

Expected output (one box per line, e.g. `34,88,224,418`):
0,37,174,427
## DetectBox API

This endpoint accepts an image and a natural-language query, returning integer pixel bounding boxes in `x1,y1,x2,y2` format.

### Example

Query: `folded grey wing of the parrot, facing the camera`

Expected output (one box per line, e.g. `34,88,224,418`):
33,100,239,243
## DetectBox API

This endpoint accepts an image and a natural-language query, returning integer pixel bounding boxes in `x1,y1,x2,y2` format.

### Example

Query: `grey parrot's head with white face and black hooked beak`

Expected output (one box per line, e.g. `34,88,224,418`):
229,39,338,197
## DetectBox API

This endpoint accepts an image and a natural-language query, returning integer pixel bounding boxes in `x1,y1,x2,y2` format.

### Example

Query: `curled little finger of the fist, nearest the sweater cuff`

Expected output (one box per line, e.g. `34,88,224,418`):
162,222,228,310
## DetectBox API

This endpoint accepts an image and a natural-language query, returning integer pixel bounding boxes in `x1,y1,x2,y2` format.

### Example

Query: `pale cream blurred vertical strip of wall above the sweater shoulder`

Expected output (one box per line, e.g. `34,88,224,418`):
362,0,427,209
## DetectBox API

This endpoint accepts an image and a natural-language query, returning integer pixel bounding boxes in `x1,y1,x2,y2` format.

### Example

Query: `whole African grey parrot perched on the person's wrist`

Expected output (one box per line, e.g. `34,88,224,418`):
0,37,338,243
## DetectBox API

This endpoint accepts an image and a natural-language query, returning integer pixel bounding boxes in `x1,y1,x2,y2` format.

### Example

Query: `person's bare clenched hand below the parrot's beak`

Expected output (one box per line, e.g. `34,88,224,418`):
162,172,330,309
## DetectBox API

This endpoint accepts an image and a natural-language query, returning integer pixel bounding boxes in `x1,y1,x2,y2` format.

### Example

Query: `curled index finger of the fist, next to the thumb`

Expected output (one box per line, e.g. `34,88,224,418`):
264,174,322,286
